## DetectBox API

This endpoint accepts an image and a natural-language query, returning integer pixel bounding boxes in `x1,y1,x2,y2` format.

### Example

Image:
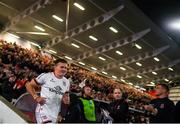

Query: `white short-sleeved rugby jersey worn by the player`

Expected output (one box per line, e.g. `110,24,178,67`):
35,72,70,118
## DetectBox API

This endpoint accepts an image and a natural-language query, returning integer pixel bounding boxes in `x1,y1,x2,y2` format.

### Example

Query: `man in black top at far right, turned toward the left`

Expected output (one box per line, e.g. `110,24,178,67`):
144,84,175,123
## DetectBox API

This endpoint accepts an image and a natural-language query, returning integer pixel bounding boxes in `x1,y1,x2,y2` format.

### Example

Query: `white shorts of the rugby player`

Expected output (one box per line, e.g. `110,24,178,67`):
35,106,57,124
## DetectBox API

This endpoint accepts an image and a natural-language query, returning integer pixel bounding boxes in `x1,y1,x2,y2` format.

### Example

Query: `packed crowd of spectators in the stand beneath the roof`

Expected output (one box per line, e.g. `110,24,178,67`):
0,40,150,105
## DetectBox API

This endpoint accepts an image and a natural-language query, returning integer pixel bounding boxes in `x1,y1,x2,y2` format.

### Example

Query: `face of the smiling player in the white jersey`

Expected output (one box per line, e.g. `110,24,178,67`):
54,62,68,76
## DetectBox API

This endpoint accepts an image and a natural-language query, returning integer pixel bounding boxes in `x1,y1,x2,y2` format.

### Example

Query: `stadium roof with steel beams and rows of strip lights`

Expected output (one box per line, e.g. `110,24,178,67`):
0,0,180,86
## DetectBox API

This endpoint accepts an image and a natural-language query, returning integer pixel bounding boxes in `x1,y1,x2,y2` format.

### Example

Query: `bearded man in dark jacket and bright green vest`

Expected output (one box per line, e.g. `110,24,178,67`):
66,85,107,123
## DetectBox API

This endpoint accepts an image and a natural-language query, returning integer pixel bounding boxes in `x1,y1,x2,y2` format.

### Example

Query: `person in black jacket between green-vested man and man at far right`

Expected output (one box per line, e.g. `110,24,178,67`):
110,87,129,123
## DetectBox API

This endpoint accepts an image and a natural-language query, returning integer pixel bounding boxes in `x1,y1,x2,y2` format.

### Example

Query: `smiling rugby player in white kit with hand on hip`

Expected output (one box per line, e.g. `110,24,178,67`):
26,59,70,124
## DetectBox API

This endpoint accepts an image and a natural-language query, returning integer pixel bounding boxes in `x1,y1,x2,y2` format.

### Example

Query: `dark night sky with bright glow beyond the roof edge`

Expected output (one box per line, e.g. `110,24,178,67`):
132,0,180,44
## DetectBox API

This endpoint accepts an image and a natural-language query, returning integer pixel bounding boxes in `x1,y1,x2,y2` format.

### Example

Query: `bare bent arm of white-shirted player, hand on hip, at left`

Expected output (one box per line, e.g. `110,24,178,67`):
26,79,45,105
